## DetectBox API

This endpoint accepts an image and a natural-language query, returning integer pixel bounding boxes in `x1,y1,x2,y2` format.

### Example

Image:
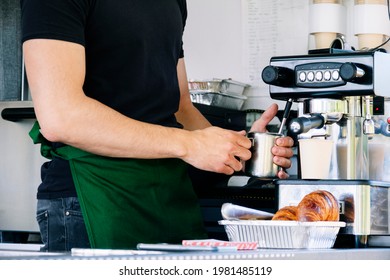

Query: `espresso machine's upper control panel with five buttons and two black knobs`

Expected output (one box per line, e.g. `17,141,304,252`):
262,51,390,101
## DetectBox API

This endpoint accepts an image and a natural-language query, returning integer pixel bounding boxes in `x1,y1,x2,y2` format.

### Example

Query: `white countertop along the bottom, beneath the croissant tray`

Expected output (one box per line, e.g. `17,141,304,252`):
0,243,390,260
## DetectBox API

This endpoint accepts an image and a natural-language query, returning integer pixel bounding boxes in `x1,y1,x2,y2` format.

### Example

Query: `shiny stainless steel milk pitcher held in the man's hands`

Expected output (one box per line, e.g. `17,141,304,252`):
243,132,282,178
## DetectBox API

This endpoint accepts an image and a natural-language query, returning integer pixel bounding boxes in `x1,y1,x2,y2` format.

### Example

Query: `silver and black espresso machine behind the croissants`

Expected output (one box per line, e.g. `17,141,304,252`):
262,49,390,247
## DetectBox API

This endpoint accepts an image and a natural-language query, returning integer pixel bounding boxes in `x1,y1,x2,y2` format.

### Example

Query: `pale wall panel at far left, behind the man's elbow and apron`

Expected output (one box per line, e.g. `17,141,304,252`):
0,101,45,232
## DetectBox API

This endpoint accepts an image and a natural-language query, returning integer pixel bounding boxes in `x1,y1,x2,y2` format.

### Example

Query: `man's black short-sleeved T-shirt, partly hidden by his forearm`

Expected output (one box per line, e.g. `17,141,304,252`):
21,0,187,198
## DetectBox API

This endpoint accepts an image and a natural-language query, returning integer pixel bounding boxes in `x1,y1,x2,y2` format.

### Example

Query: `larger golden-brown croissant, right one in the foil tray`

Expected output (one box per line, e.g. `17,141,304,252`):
297,190,340,222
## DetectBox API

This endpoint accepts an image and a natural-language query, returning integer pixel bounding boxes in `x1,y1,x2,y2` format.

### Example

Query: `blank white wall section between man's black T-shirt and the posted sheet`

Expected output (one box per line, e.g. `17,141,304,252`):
184,0,244,80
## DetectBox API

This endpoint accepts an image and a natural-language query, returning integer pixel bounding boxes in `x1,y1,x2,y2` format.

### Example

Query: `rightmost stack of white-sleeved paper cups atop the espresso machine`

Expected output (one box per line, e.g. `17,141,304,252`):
354,0,390,49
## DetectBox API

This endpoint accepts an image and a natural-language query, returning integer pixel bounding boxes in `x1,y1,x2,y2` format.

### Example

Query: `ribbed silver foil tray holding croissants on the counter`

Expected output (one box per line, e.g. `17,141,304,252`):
218,220,346,249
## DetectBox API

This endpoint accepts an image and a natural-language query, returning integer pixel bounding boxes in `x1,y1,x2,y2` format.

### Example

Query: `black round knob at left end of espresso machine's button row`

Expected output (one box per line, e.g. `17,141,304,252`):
261,65,294,87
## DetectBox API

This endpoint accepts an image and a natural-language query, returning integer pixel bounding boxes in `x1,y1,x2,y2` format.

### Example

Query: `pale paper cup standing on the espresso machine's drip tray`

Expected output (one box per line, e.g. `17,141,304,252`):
298,138,333,179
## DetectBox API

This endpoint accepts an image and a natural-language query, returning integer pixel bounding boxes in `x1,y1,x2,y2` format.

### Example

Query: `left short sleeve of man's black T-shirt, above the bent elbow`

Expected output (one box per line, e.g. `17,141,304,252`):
21,0,90,45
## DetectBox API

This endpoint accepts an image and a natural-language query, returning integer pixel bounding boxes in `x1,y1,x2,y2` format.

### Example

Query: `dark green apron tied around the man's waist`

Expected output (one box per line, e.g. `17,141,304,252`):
30,123,207,249
